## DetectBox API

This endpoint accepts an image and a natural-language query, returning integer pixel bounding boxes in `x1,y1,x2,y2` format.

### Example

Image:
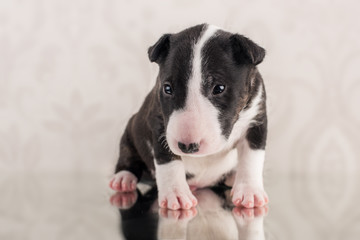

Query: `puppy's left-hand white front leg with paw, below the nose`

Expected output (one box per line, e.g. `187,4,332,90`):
155,160,197,210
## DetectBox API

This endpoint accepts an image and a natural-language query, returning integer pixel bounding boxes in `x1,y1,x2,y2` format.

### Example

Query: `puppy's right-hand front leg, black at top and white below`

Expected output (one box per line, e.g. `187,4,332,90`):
232,121,269,208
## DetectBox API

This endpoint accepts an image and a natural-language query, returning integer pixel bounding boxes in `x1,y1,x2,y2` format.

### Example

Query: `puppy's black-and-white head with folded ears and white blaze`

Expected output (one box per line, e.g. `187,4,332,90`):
148,24,265,156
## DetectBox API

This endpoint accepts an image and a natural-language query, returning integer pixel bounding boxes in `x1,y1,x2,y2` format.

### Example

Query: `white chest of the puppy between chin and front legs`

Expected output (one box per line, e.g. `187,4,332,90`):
182,149,237,188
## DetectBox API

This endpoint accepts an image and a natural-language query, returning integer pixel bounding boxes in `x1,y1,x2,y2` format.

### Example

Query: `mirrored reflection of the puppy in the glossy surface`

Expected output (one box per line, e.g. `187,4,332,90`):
111,188,267,240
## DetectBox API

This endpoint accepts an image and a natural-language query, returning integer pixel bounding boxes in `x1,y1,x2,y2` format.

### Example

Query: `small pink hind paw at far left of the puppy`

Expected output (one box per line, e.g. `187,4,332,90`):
109,170,137,192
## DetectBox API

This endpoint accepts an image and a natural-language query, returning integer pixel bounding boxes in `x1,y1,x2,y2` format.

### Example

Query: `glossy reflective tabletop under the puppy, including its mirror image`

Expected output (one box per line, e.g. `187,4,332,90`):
0,173,360,240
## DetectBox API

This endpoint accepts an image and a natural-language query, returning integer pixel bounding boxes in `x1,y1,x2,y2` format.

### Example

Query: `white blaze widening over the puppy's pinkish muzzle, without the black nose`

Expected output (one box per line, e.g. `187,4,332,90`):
166,25,226,156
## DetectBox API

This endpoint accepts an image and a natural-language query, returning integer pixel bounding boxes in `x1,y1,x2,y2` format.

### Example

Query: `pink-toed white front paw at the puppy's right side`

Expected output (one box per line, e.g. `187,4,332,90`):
231,183,269,208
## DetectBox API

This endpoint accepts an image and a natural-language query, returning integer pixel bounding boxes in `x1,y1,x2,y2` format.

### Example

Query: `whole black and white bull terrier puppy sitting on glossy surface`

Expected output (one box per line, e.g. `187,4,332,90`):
110,24,268,209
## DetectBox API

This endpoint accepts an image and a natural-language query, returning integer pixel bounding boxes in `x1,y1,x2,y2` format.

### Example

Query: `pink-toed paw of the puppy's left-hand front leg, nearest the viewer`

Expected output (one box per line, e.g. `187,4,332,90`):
159,186,197,210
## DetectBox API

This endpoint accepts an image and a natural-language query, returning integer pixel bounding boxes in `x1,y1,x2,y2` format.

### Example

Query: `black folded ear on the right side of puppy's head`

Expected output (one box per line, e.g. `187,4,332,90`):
230,34,265,65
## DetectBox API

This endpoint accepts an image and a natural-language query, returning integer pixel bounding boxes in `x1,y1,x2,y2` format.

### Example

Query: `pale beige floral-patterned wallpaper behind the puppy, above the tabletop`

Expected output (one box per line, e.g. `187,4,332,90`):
0,0,360,176
